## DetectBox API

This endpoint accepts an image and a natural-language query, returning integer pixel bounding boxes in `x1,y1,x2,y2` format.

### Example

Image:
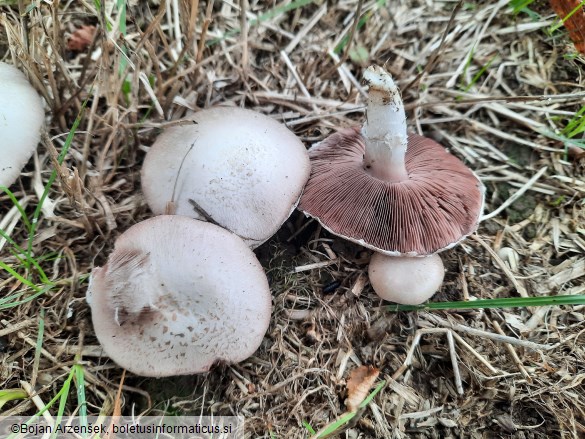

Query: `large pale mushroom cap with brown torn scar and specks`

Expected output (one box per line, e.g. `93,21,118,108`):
87,215,271,377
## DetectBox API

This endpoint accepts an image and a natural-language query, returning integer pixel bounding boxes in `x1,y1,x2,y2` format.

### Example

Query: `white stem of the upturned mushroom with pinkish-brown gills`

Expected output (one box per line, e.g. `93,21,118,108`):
362,66,408,182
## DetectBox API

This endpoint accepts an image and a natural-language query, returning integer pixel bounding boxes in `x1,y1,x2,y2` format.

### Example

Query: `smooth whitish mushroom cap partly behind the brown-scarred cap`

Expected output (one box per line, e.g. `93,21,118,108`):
142,107,310,248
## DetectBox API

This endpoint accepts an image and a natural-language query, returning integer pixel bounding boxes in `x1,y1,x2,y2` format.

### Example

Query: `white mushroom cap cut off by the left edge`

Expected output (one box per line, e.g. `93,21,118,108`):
0,62,45,187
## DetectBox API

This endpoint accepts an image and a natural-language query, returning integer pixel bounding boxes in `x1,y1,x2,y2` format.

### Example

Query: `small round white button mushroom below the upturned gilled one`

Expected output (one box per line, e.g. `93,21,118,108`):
368,253,445,305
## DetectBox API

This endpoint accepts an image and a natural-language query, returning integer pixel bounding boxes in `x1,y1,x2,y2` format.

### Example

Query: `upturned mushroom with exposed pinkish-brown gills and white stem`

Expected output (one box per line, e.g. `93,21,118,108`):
299,66,484,301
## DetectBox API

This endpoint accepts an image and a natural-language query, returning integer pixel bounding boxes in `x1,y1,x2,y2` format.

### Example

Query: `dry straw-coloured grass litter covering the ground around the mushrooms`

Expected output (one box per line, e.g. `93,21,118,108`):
0,0,585,438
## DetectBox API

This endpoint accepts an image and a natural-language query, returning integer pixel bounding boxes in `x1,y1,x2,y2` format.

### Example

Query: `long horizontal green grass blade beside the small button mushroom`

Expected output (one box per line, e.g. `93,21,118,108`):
386,295,585,312
